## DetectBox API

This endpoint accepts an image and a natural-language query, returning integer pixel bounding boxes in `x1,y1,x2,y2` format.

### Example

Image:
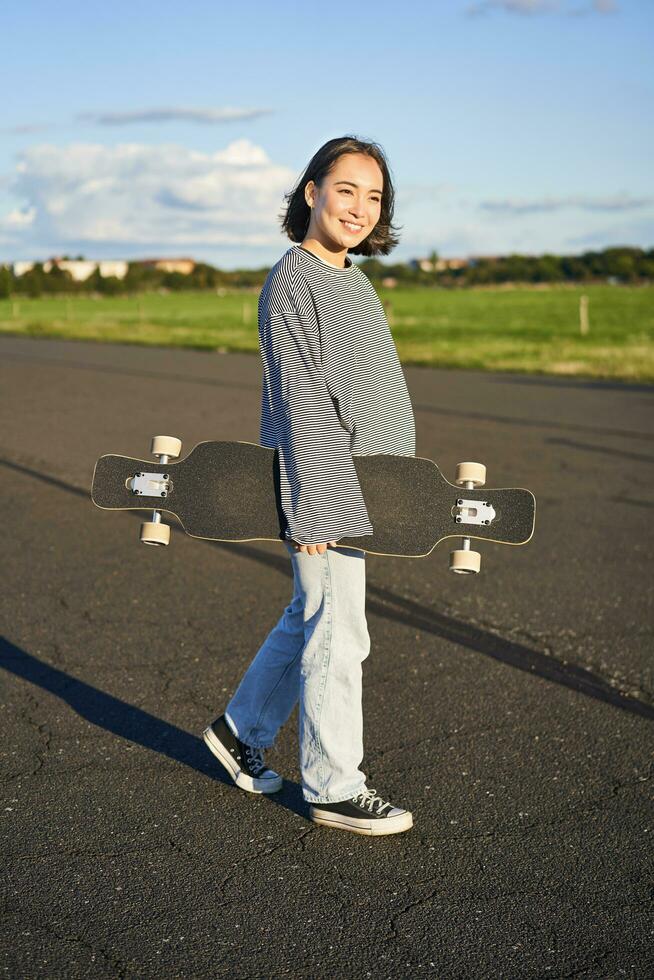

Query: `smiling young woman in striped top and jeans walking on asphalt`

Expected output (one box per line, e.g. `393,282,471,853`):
204,136,415,835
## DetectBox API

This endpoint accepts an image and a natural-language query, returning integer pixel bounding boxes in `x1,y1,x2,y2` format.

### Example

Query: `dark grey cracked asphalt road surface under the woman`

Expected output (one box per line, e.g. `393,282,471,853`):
0,337,654,980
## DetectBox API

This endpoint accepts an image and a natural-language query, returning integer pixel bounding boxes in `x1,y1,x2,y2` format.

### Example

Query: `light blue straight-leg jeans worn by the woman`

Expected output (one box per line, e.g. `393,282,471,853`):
225,542,370,803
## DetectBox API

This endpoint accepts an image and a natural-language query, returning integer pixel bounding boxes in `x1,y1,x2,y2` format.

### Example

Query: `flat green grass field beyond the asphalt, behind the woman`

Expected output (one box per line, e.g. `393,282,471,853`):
0,285,654,381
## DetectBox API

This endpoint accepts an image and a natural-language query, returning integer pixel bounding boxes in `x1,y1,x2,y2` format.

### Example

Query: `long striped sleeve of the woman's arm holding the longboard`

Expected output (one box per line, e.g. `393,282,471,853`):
259,272,373,544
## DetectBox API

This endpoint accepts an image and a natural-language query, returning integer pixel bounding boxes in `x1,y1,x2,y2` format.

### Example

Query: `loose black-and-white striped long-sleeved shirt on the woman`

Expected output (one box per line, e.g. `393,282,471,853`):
258,238,415,544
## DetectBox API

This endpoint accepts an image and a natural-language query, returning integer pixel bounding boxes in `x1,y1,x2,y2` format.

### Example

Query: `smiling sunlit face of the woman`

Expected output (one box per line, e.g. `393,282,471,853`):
304,153,384,251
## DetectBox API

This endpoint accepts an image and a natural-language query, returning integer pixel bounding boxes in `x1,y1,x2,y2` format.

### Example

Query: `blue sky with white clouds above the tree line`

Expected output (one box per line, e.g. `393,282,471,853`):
0,0,654,269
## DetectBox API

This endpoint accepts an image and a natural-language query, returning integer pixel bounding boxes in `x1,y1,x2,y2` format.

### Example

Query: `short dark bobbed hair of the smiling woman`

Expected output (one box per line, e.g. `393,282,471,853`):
280,135,401,256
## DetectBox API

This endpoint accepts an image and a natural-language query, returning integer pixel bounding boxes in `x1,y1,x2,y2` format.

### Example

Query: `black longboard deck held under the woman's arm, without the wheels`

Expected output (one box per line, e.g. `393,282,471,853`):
91,441,536,558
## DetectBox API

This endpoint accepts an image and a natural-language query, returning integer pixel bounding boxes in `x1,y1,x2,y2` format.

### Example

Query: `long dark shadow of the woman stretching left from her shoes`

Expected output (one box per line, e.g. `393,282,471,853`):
0,637,308,817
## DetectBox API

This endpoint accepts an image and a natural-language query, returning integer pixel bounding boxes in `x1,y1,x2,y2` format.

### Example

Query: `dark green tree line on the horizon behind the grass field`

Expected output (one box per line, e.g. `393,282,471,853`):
0,246,654,298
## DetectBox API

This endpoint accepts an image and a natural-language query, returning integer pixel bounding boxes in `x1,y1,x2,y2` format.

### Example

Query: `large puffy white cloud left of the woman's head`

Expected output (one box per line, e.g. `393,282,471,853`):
0,139,297,247
